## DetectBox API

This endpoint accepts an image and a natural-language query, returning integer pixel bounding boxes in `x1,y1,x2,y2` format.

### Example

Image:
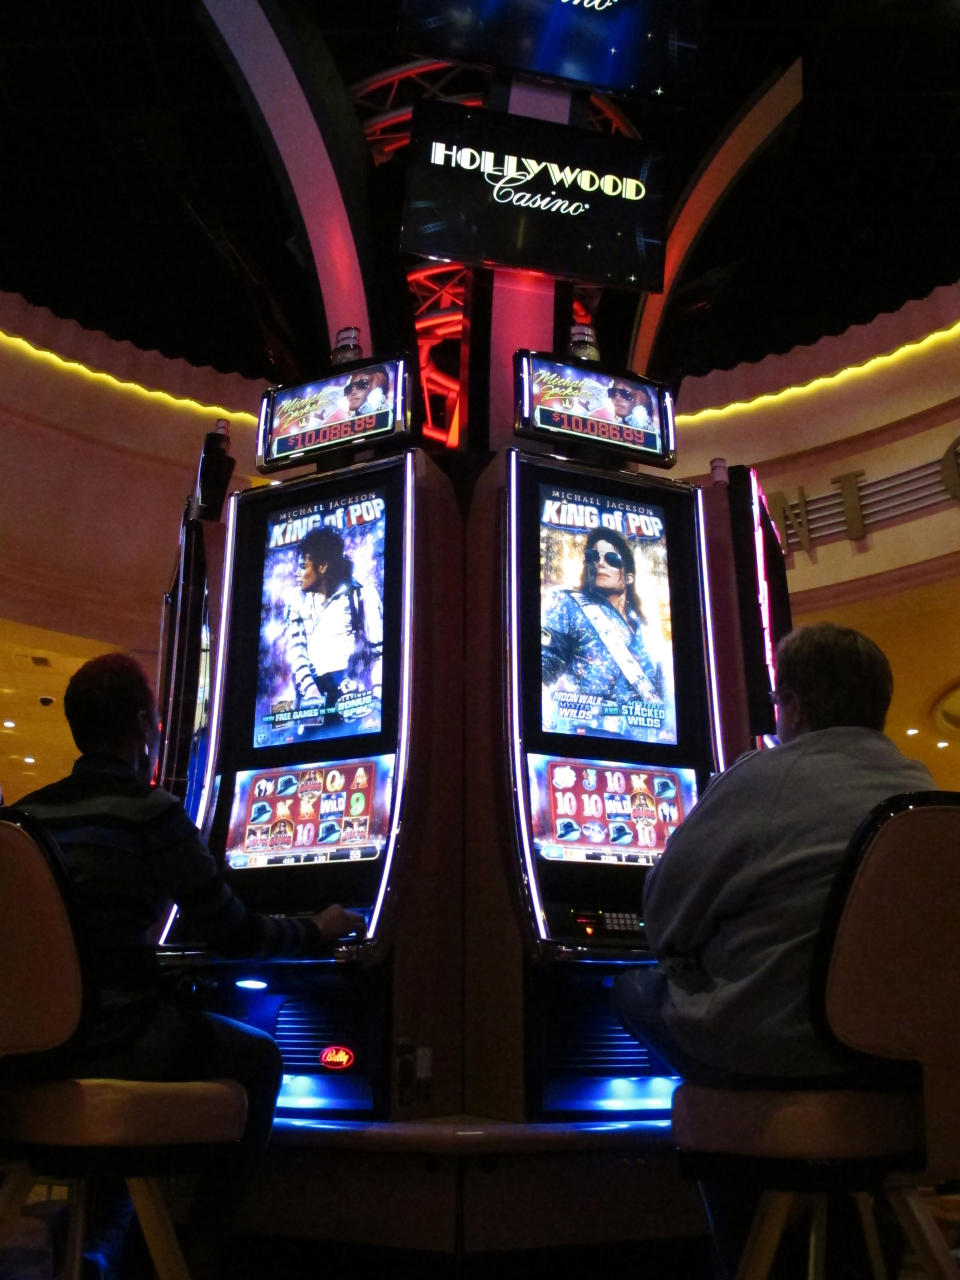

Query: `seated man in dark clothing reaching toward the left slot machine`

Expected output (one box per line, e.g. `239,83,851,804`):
10,653,365,1274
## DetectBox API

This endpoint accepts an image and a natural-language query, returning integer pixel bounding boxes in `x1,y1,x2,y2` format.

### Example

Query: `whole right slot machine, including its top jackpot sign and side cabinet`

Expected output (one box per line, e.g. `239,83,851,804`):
465,351,722,1120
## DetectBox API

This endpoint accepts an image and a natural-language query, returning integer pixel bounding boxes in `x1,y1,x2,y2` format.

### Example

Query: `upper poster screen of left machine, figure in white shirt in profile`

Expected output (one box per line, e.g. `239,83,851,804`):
259,484,388,749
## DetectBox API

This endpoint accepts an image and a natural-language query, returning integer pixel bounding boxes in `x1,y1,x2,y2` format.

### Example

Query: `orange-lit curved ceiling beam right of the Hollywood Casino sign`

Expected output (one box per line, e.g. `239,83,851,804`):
630,59,803,374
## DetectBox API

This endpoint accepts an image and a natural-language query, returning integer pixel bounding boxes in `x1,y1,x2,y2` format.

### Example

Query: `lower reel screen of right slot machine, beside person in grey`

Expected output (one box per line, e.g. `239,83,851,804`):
527,754,696,867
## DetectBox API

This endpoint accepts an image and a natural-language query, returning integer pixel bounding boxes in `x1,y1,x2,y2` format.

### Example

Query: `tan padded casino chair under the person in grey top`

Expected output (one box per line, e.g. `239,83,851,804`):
672,791,960,1280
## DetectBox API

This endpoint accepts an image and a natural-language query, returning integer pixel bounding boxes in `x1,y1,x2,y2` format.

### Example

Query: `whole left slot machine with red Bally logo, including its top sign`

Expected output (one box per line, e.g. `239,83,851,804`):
161,358,462,1119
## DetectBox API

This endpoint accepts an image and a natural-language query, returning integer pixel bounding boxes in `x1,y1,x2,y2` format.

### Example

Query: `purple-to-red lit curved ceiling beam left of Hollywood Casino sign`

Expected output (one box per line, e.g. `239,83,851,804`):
204,0,372,355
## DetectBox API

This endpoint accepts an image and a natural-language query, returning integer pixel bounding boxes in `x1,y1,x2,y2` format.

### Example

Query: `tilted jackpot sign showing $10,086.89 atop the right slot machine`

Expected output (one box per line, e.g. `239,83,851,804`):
513,351,677,467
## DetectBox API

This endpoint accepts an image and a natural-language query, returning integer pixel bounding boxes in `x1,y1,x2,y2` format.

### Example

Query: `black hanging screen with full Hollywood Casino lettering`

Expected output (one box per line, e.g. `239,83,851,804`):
402,102,666,291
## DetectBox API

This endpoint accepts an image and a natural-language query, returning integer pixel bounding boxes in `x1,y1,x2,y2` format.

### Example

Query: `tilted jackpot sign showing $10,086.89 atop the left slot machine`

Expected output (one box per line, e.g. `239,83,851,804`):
257,358,410,472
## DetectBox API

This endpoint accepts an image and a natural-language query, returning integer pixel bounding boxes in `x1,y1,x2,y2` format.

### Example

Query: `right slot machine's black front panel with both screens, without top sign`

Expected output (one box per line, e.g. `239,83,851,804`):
507,452,714,945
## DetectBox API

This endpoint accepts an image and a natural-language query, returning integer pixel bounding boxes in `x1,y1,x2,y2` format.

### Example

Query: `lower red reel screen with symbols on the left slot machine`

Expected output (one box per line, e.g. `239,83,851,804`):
224,755,394,872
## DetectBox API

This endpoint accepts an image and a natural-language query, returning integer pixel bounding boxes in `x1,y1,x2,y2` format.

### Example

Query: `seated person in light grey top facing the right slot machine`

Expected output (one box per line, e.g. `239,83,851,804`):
616,623,936,1087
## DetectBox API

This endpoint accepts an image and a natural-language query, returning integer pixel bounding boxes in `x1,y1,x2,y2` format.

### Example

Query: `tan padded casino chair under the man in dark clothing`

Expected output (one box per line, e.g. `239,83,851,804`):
0,809,247,1280
